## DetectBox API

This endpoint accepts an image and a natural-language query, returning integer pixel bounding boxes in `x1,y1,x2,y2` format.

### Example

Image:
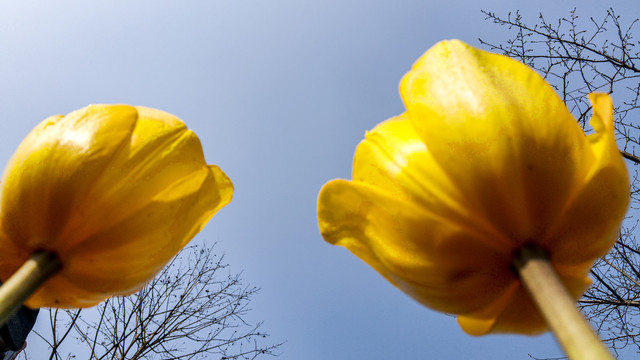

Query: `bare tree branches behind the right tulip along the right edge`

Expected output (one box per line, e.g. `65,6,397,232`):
480,9,640,352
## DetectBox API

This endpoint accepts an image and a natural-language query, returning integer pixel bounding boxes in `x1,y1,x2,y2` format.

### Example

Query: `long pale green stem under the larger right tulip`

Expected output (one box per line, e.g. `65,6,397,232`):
514,245,613,360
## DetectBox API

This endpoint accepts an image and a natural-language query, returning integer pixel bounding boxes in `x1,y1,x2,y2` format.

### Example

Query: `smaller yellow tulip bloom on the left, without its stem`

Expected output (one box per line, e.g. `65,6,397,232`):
0,105,233,307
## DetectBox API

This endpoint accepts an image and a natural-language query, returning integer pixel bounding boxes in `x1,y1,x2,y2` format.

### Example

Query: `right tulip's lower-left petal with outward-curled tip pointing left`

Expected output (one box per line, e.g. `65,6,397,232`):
318,180,515,313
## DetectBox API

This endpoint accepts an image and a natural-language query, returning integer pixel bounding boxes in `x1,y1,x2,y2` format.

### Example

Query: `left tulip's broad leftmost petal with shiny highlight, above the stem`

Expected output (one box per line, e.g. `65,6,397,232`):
0,105,137,253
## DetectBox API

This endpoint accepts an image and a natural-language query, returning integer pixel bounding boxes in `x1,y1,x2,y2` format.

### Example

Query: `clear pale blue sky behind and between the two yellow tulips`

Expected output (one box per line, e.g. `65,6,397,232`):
0,0,640,360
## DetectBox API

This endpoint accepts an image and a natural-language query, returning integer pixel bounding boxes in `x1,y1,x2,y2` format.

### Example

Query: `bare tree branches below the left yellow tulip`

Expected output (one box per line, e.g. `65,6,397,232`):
21,246,281,360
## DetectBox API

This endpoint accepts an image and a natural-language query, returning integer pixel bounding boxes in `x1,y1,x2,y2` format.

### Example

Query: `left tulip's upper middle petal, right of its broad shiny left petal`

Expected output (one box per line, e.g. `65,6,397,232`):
57,108,214,249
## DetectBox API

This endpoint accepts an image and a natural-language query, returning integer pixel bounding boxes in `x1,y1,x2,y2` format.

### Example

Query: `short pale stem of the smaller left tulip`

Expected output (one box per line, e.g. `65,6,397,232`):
0,251,62,326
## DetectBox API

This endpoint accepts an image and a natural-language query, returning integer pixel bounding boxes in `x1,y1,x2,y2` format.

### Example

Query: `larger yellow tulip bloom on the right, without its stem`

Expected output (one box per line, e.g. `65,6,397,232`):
318,41,629,335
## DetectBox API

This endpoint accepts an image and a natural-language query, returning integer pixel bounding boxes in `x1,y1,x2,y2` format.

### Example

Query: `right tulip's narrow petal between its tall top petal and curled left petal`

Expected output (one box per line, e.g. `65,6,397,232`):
353,115,515,254
